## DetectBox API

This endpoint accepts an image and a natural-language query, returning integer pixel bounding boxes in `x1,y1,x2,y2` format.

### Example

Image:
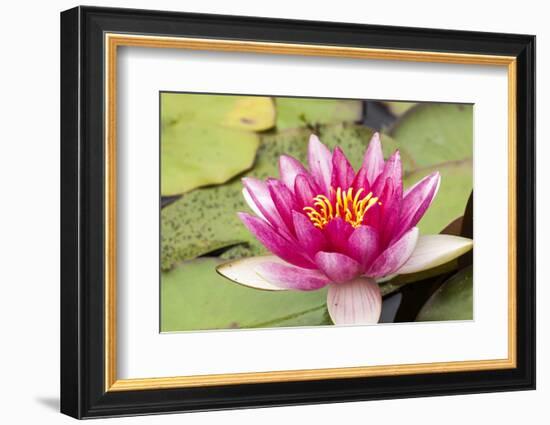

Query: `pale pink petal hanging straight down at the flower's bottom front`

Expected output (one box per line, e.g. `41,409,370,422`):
327,277,382,325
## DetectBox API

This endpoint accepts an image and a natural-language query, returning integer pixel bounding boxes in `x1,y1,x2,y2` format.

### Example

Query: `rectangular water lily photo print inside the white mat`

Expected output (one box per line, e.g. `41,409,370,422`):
159,92,474,332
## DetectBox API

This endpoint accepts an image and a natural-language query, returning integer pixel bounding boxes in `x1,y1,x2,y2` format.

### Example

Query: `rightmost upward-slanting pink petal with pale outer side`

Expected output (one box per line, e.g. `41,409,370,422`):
397,171,441,238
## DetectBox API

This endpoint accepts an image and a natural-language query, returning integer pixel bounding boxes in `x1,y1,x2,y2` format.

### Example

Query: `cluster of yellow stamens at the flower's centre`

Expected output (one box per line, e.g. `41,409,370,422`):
304,187,380,229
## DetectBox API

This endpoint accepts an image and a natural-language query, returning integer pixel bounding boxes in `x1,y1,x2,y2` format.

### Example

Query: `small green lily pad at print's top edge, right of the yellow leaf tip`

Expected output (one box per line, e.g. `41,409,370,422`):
275,97,363,130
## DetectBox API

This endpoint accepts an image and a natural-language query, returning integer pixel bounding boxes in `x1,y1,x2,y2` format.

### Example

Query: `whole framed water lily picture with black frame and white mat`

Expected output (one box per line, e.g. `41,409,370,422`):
61,7,535,418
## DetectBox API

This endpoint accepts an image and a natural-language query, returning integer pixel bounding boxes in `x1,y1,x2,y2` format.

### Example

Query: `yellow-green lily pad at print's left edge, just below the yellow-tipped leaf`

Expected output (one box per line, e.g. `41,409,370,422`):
161,122,260,196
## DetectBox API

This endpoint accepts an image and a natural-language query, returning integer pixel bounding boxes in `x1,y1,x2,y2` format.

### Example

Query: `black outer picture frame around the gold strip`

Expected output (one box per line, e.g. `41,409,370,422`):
61,7,535,418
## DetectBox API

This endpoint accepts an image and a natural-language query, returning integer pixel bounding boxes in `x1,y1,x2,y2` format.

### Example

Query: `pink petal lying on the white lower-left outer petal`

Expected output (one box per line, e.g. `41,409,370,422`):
256,262,329,291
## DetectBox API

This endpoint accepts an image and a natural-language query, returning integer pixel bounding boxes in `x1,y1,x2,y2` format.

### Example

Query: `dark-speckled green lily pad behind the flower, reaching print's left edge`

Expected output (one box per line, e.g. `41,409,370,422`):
161,125,396,270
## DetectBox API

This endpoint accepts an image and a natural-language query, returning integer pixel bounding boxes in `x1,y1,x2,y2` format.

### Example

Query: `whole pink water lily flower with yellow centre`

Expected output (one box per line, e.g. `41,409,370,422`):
218,133,472,324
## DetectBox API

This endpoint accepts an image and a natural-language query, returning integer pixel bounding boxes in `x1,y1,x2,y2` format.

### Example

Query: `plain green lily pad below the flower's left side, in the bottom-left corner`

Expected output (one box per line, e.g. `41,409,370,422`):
161,258,331,332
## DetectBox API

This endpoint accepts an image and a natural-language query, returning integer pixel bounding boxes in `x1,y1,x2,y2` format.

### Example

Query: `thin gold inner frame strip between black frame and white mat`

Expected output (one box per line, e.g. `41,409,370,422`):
104,33,517,391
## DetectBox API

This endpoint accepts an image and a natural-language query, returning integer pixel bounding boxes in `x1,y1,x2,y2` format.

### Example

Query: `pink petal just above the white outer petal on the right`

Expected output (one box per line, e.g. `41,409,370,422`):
368,227,418,277
